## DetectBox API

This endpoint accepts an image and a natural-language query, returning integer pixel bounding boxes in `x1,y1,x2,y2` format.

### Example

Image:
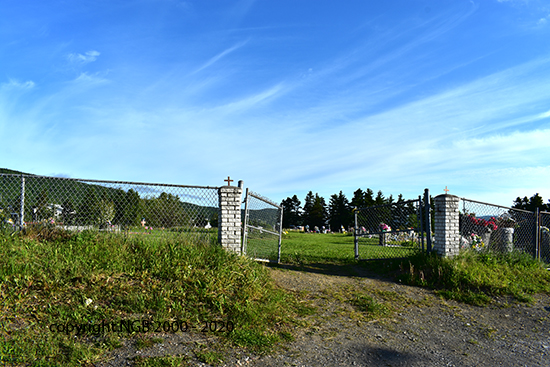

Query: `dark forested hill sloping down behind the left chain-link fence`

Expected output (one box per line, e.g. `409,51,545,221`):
0,168,218,227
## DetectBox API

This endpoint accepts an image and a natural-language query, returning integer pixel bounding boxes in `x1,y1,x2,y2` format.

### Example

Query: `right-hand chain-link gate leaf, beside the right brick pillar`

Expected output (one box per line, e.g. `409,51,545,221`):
354,200,423,260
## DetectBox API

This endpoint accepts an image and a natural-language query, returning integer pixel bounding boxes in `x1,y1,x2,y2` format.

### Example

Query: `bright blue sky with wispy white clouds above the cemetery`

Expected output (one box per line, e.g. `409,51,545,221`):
0,0,550,206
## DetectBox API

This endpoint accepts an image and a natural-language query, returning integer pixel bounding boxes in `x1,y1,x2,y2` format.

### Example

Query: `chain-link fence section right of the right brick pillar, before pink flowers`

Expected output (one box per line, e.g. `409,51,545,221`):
459,199,537,256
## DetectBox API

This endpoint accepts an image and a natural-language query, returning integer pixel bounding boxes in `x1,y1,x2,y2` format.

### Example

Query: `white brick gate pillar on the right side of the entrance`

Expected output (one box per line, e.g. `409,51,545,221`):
434,194,460,257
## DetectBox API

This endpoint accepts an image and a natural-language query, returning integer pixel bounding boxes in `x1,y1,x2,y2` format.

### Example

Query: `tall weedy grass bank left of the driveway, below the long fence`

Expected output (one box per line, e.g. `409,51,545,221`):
0,232,301,366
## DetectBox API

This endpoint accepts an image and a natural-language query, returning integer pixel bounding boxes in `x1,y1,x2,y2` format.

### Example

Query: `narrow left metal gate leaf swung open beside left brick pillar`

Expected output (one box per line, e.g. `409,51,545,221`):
242,189,283,263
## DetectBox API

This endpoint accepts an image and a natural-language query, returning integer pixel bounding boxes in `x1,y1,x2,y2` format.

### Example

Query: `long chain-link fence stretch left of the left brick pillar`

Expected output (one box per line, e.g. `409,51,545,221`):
0,174,219,242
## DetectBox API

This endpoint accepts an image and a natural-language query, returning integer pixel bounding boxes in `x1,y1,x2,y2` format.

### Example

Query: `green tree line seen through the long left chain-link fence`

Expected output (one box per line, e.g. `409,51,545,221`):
0,184,218,228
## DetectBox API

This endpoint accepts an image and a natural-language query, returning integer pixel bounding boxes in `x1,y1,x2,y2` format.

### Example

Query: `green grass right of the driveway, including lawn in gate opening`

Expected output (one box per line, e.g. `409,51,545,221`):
281,232,550,305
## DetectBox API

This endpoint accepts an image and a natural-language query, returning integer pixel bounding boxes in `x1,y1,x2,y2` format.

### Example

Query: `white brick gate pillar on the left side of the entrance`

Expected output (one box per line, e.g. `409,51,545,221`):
218,181,243,254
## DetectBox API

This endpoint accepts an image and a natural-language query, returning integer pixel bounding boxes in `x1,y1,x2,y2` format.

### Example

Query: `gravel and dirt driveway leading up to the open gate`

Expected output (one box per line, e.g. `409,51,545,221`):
100,266,550,367
